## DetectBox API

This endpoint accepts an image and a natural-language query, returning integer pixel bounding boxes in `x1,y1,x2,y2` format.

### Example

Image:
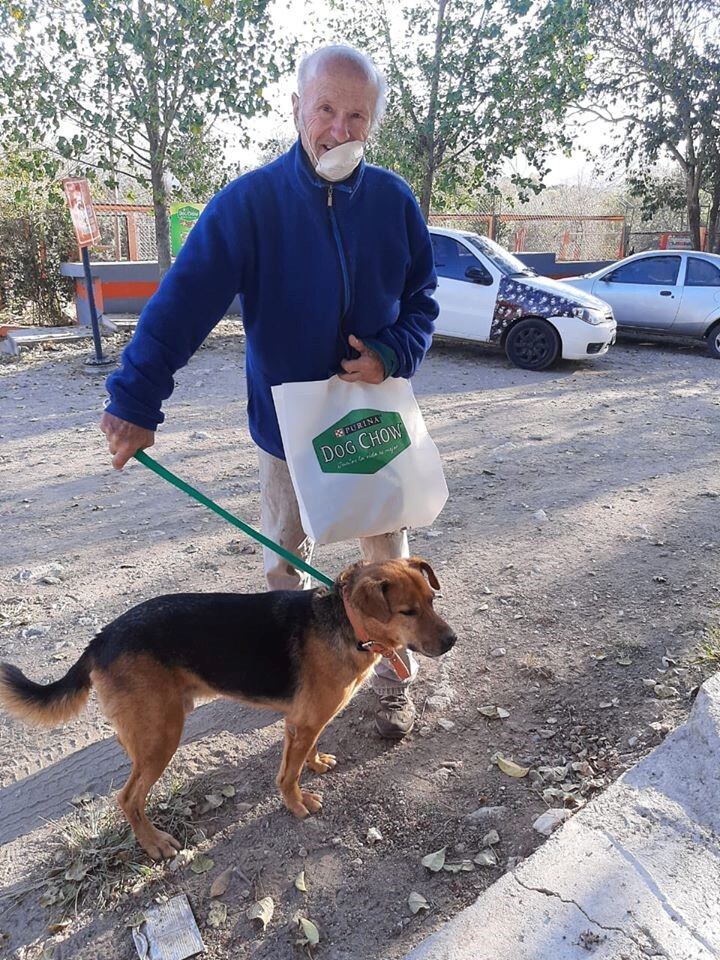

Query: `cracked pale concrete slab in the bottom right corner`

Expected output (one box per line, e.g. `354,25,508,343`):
406,674,720,960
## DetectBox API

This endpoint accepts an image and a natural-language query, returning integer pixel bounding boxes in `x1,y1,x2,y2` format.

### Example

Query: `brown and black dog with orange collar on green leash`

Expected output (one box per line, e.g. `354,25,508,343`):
0,557,456,859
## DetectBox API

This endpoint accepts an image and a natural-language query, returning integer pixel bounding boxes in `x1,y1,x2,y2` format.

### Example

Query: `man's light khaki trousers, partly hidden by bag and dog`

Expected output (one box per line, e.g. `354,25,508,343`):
258,450,418,693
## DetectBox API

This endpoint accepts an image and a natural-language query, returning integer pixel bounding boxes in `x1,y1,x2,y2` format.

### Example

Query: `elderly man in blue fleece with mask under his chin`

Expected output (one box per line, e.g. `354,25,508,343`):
100,46,438,739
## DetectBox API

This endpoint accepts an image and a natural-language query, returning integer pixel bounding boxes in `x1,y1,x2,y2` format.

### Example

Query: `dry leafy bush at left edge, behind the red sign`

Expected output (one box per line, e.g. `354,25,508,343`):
0,149,77,324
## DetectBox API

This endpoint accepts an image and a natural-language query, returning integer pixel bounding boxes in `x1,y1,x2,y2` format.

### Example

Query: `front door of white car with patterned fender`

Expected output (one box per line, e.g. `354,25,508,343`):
430,233,500,340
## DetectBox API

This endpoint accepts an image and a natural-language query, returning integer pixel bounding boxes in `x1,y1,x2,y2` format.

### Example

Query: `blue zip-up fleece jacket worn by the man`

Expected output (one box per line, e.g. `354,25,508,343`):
106,141,438,457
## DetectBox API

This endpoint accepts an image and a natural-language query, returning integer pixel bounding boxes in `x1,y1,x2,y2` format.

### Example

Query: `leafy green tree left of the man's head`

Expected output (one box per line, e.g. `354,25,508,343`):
0,0,290,275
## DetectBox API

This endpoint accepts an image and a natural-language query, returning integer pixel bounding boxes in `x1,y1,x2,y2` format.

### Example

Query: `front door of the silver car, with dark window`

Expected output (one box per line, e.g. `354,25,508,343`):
592,254,682,330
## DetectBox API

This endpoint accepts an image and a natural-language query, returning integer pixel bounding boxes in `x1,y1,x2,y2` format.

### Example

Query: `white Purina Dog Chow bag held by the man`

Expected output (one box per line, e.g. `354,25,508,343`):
272,377,448,543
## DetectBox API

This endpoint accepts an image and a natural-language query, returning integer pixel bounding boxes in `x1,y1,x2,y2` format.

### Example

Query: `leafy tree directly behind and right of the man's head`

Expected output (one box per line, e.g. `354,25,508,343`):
336,0,586,217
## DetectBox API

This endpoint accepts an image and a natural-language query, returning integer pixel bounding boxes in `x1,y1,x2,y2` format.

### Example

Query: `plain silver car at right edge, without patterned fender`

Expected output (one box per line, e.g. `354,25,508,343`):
562,250,720,359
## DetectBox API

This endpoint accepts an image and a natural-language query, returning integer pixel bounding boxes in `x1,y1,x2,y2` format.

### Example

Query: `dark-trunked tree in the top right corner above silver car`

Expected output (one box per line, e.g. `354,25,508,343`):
582,0,720,249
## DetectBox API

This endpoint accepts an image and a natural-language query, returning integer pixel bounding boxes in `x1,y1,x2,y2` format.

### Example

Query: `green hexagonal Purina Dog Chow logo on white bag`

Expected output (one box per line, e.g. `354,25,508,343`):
313,410,410,473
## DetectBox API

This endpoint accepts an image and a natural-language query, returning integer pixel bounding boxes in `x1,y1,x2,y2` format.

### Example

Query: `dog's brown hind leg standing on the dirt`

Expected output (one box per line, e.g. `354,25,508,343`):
118,692,185,860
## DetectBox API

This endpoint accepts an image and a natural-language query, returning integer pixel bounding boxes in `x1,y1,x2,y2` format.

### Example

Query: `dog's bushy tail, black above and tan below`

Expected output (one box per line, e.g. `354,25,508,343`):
0,650,92,727
